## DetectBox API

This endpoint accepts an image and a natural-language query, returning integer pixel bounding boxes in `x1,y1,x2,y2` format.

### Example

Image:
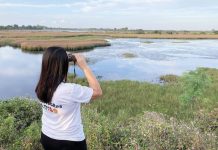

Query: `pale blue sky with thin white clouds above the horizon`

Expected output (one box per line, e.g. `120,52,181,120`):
0,0,218,30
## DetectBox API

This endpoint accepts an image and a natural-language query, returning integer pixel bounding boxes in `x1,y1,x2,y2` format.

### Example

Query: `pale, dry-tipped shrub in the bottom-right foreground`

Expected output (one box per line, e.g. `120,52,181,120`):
115,112,218,150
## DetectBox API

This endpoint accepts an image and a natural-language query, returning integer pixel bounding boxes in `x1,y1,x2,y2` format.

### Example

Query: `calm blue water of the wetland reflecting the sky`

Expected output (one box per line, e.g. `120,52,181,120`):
0,39,218,98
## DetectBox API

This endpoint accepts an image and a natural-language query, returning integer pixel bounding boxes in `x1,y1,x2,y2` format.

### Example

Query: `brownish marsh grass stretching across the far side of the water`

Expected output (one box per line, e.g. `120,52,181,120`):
0,30,218,51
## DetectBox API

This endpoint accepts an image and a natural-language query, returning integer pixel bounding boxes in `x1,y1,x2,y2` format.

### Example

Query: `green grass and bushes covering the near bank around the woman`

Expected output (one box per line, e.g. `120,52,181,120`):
0,68,218,150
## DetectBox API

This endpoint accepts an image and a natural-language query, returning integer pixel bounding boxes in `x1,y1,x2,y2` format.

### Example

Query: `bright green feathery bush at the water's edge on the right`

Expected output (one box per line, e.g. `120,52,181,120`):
181,69,211,104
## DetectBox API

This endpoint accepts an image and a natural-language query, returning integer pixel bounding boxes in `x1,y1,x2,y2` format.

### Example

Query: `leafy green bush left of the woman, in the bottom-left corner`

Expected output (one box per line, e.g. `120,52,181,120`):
0,98,42,150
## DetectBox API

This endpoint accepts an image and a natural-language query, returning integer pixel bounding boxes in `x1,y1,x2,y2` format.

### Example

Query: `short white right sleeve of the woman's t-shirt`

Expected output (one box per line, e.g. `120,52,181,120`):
70,84,93,103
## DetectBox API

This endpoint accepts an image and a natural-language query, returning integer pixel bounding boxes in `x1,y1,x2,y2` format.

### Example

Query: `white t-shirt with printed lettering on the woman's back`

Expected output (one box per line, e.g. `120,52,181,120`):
40,83,93,141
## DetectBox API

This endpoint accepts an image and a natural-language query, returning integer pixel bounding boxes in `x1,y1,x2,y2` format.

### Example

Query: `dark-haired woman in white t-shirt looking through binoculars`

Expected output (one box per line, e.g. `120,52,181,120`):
35,47,102,150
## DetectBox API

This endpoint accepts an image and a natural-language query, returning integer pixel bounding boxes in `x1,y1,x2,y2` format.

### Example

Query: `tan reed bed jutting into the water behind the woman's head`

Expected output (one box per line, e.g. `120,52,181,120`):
0,31,110,51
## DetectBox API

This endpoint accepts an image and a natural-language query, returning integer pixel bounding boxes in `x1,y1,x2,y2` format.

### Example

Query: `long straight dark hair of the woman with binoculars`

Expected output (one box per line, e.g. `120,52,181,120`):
35,47,69,103
